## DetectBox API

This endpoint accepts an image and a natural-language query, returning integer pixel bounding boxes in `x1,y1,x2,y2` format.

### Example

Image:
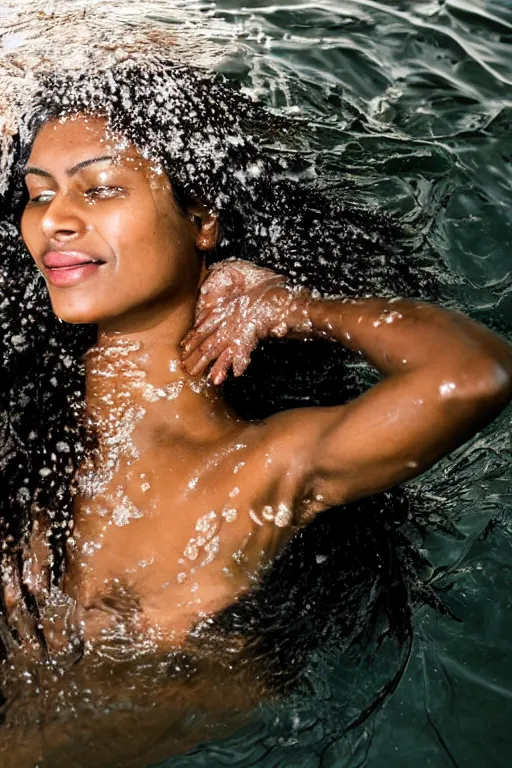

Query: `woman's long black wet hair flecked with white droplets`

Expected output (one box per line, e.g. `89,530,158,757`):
0,1,448,732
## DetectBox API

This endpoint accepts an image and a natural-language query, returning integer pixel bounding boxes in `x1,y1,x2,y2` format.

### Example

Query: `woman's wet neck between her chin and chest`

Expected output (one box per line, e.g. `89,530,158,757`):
84,307,240,441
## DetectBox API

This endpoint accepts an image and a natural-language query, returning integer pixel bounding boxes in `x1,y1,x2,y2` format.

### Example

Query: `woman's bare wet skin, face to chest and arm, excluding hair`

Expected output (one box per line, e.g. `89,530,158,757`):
11,116,512,760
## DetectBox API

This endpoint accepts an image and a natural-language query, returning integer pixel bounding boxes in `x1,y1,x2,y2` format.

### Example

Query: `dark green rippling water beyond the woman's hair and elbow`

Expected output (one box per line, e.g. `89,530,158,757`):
155,0,512,768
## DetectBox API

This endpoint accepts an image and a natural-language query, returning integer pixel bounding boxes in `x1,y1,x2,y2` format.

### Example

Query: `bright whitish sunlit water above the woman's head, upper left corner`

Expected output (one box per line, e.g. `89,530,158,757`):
0,0,236,194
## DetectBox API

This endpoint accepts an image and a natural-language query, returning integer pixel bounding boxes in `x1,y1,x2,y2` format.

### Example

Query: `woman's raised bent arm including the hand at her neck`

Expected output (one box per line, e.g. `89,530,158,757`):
181,262,512,507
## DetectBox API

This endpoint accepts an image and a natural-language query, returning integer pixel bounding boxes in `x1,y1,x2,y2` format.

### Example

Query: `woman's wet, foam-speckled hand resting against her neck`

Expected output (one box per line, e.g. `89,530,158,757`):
182,260,307,385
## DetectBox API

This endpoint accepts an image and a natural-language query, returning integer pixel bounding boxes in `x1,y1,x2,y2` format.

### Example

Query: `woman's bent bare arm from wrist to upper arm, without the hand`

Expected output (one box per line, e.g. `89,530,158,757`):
278,299,512,506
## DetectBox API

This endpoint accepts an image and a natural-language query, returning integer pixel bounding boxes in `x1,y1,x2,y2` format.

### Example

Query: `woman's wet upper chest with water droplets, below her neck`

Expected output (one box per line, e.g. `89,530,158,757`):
68,430,296,637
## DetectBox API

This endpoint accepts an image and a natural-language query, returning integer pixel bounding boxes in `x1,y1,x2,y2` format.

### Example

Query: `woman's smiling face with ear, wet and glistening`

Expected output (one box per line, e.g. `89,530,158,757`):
21,115,217,330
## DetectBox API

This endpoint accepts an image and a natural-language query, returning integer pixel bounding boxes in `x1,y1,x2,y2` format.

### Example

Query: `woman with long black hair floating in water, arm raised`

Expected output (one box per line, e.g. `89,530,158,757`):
2,16,512,766
